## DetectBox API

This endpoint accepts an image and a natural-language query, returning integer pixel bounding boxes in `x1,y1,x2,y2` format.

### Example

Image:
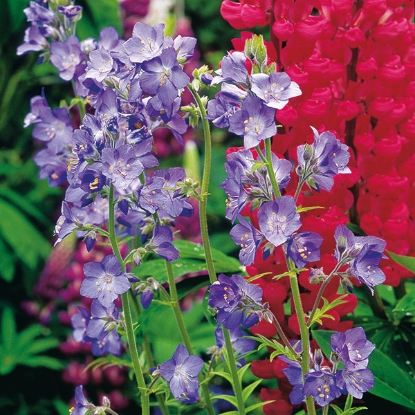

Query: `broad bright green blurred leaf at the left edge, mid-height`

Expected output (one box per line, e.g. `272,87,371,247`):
0,199,51,269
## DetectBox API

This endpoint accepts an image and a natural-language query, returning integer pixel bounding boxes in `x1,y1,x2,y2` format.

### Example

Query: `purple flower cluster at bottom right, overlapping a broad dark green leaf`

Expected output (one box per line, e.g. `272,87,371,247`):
279,327,375,406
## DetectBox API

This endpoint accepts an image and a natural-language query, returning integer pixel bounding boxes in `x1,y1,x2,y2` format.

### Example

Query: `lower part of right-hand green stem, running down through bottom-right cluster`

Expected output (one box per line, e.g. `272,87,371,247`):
290,273,316,415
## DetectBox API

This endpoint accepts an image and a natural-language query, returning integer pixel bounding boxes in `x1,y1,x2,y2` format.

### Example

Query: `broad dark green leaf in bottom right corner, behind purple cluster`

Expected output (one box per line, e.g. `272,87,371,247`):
312,330,415,409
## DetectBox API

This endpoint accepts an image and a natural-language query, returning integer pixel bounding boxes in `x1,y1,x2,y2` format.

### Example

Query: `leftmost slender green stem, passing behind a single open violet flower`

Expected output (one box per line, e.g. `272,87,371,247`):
108,184,150,415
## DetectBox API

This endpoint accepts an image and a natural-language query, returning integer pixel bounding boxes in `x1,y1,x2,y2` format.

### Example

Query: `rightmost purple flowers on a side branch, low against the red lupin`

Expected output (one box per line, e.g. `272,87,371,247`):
334,225,386,294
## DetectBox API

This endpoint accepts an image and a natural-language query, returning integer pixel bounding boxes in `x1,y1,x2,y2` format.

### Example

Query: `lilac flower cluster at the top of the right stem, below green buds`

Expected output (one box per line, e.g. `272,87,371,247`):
207,52,301,149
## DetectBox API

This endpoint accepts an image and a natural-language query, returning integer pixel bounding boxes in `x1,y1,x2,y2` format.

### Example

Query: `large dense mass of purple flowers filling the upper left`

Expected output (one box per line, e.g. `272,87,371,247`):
24,13,196,261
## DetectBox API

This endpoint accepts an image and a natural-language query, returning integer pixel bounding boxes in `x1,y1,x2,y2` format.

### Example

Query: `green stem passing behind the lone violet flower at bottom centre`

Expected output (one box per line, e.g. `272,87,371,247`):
165,261,215,415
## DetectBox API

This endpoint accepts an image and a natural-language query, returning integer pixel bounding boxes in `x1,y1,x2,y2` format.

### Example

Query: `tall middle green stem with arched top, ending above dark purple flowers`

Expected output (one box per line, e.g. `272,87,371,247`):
188,84,217,284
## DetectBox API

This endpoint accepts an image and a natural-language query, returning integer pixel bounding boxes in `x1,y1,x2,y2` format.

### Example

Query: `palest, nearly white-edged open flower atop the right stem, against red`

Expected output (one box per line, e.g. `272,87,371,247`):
251,72,301,110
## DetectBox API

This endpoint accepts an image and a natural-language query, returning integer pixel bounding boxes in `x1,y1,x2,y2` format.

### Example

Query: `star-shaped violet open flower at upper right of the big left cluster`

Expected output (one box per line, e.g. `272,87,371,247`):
140,48,190,105
